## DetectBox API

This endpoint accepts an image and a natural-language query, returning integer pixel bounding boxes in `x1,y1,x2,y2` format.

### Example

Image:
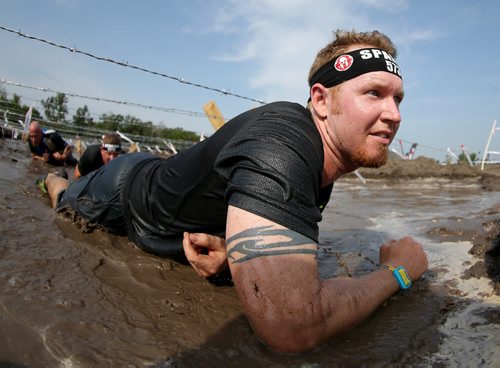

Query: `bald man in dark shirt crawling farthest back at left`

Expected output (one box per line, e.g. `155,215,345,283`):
28,121,78,166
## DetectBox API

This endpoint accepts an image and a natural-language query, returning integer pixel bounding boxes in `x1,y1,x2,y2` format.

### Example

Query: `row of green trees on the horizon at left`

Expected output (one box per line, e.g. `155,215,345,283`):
0,87,199,142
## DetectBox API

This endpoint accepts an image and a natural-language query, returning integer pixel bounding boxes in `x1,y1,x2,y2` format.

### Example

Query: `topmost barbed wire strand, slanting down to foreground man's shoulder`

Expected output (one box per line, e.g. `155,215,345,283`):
0,25,266,105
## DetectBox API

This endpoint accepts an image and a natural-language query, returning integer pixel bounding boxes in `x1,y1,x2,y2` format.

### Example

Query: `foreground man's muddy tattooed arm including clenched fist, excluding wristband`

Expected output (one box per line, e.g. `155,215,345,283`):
226,206,427,352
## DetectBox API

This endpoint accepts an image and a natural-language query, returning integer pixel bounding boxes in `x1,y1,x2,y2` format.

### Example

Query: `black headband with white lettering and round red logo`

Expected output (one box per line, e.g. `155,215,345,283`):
309,48,402,88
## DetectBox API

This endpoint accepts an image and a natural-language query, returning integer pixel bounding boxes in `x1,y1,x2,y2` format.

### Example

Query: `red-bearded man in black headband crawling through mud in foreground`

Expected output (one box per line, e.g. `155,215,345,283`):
36,30,427,352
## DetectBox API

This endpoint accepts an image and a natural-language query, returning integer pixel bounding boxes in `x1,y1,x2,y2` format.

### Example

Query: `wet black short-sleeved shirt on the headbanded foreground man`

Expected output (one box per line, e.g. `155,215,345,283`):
124,102,332,253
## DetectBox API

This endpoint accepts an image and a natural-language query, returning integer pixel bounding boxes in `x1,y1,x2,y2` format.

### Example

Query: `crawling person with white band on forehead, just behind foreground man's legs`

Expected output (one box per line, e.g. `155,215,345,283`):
75,133,122,178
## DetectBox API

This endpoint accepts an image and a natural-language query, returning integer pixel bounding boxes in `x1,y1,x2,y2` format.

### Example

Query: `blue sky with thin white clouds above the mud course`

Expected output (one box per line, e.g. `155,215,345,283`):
0,0,500,161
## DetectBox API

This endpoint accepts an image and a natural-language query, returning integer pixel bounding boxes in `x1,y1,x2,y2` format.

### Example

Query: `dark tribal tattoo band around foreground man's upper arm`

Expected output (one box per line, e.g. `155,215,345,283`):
226,226,317,263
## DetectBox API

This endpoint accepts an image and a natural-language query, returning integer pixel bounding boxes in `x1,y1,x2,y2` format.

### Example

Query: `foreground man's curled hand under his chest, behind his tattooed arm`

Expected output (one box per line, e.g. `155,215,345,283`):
182,232,227,277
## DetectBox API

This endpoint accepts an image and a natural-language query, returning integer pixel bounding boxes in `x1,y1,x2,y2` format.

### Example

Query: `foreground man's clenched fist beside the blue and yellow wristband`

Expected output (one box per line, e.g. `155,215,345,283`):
379,236,428,281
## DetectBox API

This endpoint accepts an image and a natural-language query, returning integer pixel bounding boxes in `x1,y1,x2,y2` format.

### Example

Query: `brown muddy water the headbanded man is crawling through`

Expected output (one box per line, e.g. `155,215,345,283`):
0,139,500,367
